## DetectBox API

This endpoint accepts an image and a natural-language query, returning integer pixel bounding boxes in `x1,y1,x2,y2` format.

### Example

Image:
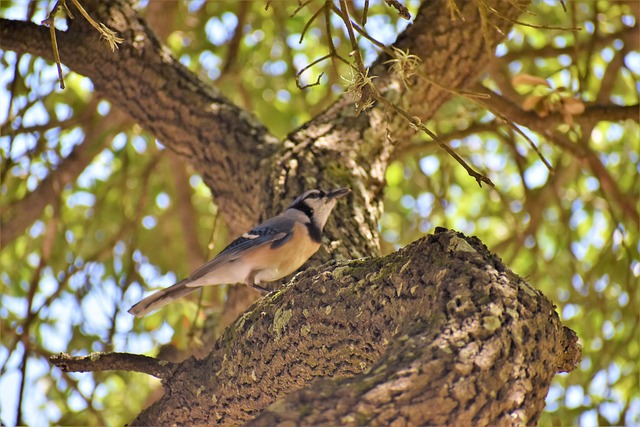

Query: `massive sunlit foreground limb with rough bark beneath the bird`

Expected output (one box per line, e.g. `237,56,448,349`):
133,229,580,426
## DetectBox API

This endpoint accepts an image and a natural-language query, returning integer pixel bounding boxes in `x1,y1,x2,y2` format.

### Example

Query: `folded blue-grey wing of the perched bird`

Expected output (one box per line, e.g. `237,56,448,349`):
189,215,293,282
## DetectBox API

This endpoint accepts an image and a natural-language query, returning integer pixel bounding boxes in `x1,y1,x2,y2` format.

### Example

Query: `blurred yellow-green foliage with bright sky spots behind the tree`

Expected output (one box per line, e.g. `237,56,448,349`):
0,1,640,426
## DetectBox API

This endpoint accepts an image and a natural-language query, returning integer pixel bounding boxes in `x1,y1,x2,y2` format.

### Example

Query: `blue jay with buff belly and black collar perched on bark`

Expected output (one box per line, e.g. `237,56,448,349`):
129,188,351,317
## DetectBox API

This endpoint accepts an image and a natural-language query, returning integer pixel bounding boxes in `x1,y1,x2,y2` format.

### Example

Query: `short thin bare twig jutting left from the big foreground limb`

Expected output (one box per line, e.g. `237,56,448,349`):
49,353,178,380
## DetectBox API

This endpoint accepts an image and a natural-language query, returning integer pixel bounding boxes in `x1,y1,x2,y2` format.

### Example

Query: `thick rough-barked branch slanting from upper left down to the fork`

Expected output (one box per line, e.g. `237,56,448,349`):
0,9,279,237
